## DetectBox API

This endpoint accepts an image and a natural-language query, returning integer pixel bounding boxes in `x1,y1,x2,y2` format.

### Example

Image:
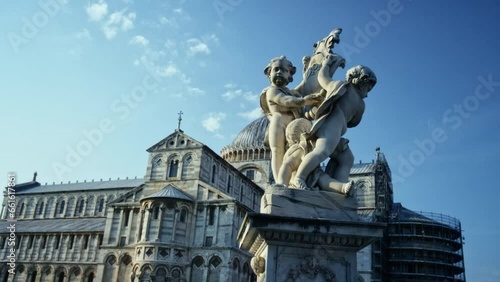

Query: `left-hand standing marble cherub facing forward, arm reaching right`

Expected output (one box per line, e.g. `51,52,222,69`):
260,56,322,181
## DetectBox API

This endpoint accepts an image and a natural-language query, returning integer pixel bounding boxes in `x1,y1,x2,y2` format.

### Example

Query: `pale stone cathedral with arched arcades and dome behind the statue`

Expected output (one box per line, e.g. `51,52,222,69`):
0,117,465,282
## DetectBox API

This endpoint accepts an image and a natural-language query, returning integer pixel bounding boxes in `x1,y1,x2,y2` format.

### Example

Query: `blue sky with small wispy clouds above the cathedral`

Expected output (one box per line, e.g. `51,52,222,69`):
0,0,500,282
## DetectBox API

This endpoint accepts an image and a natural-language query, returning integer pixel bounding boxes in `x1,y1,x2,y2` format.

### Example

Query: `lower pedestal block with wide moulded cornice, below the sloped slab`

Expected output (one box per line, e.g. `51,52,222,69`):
238,213,385,282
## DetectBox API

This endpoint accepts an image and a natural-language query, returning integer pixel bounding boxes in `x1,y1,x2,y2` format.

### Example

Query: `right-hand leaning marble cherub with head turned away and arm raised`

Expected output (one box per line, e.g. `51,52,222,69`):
291,54,377,189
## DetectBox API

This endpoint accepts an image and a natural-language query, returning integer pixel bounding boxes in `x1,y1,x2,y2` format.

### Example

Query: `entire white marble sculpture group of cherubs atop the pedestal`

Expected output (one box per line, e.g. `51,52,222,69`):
260,28,377,195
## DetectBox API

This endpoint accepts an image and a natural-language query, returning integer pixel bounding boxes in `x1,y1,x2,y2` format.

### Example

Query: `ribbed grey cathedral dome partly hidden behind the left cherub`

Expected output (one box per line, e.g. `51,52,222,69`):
221,116,270,162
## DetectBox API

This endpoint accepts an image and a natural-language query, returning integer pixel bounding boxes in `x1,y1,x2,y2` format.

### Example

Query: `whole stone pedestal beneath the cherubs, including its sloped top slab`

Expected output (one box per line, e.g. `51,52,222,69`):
238,187,385,282
